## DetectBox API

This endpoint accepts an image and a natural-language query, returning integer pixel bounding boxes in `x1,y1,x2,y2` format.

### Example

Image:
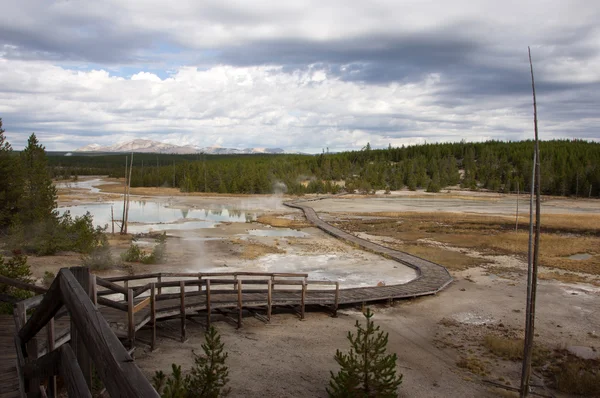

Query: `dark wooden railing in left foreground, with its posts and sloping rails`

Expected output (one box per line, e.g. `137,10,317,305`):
15,268,158,397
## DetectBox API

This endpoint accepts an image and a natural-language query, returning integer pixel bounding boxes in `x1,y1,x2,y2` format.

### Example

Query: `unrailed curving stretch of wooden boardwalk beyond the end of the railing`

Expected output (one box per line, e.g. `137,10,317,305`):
284,199,452,304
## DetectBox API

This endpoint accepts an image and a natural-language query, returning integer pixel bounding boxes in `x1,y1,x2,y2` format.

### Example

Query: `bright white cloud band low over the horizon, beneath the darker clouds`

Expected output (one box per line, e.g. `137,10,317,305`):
0,60,589,152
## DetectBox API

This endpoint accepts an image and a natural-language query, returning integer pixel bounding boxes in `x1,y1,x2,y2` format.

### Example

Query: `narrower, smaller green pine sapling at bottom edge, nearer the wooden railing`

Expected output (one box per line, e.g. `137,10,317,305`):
187,326,229,398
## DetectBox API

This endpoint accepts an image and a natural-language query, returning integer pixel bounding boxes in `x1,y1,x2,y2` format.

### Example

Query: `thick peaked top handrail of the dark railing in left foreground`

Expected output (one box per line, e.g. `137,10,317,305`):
18,268,159,398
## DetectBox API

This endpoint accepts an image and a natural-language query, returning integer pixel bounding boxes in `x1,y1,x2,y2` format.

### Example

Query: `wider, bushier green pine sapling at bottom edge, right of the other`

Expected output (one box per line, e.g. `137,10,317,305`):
327,309,402,398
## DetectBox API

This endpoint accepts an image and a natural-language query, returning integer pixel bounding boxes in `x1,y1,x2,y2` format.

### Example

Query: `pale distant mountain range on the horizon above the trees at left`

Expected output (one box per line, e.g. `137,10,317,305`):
75,139,286,155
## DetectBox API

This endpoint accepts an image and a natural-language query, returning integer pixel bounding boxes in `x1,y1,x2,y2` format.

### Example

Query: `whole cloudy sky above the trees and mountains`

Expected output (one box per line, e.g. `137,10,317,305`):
0,0,600,152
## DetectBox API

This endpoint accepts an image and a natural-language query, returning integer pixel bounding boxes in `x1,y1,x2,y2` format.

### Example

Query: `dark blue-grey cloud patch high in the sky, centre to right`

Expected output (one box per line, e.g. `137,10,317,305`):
218,31,480,84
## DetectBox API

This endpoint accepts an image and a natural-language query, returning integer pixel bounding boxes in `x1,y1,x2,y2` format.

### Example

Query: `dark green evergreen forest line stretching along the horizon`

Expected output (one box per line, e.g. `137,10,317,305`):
50,140,600,197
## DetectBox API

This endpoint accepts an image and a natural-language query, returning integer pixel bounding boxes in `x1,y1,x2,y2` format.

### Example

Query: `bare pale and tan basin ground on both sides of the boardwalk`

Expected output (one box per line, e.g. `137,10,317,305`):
30,179,600,397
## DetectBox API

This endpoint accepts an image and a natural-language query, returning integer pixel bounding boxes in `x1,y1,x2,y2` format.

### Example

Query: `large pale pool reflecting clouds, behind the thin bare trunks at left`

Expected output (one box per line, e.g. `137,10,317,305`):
58,200,256,232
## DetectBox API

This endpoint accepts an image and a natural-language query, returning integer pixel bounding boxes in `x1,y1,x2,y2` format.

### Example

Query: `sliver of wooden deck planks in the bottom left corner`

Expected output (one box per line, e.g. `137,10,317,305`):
0,315,21,398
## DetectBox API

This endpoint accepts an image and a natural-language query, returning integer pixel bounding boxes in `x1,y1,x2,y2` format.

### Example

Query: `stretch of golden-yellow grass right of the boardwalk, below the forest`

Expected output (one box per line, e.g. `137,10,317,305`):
341,212,600,275
